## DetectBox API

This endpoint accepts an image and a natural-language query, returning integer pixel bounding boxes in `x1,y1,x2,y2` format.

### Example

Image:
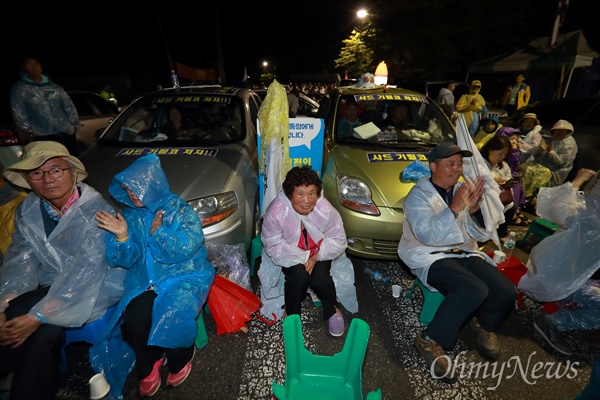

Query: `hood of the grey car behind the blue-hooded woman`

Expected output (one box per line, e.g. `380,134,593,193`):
81,143,244,208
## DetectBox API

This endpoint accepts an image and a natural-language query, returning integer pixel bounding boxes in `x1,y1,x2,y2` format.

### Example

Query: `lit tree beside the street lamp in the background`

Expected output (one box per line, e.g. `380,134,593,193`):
335,23,375,77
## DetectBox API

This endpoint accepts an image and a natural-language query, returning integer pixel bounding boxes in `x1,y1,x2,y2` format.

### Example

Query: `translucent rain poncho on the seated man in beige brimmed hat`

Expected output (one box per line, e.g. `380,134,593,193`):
0,183,126,327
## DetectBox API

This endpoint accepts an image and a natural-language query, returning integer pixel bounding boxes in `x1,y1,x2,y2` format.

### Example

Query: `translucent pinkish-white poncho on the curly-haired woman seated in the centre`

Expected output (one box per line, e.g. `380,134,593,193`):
258,191,358,319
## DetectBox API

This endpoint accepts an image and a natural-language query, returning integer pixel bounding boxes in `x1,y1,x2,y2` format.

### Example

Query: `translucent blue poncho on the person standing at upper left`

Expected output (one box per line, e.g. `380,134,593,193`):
10,74,79,139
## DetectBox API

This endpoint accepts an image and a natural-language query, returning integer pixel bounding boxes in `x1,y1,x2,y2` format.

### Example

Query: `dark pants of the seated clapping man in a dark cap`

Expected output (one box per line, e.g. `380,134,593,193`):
425,256,517,349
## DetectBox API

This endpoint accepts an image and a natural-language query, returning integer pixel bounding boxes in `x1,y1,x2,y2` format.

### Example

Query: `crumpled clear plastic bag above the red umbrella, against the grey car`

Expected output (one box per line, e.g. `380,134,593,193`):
206,243,251,290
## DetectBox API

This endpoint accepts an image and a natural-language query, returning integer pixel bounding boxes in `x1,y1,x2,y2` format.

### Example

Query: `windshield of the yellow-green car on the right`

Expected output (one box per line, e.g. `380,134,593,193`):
335,93,455,148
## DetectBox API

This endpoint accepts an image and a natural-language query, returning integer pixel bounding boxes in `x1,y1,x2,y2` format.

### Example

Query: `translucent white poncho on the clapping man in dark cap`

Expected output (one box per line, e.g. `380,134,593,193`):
398,177,496,292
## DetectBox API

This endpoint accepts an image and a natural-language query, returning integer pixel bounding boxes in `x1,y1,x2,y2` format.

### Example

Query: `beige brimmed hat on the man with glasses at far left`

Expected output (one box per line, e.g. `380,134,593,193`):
4,141,87,189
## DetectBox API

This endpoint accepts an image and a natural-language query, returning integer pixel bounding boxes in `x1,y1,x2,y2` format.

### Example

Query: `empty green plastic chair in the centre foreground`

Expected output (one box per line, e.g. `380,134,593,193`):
272,314,381,400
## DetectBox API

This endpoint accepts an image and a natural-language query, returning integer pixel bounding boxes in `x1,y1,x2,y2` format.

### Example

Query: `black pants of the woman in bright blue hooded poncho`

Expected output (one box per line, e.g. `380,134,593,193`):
121,290,194,379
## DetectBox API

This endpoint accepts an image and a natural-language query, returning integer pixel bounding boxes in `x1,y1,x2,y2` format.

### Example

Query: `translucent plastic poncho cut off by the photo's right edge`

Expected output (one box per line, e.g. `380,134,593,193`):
518,177,600,302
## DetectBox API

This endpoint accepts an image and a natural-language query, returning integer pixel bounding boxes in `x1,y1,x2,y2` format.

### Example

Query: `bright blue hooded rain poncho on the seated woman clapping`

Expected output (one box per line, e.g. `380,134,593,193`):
90,154,215,399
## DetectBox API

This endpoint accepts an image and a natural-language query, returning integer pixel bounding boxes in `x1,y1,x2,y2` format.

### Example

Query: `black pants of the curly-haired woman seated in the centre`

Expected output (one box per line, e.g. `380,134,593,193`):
281,261,338,320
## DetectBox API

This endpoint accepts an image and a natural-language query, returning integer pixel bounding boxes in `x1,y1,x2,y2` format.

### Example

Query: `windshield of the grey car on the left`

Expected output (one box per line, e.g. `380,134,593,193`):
101,93,245,146
